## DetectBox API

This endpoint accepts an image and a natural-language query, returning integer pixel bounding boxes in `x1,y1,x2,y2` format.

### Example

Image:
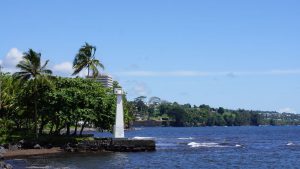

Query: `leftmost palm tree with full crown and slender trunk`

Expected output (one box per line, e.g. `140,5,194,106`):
13,49,52,138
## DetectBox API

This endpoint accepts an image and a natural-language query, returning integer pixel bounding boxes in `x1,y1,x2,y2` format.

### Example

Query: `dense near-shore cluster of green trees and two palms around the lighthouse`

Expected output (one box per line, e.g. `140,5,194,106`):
0,43,131,142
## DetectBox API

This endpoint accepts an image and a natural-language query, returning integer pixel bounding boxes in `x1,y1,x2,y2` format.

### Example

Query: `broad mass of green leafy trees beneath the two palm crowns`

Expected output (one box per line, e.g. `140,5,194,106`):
0,74,132,141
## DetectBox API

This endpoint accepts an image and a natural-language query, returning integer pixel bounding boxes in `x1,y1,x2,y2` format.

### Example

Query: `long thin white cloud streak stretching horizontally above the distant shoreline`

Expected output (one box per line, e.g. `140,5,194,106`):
115,69,300,77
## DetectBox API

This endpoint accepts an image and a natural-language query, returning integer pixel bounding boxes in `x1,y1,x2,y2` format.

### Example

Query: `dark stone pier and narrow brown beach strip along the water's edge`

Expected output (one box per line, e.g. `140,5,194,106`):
3,138,156,159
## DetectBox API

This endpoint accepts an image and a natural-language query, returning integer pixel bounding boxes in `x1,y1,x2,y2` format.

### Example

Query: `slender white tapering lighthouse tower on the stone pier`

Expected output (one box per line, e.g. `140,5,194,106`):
114,88,124,138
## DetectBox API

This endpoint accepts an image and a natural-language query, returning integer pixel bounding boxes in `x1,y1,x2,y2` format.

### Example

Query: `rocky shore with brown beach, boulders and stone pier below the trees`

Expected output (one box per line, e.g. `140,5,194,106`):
0,138,156,169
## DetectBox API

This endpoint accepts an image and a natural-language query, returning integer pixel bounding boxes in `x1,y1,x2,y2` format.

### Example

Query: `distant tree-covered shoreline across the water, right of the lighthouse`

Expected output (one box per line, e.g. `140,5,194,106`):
130,96,300,127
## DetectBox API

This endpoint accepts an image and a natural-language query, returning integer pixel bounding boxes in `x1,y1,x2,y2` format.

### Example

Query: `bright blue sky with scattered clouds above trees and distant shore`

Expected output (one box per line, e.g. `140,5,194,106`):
0,0,300,113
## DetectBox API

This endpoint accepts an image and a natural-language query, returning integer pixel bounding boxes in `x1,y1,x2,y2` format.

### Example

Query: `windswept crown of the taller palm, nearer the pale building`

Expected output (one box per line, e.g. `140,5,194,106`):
73,43,104,77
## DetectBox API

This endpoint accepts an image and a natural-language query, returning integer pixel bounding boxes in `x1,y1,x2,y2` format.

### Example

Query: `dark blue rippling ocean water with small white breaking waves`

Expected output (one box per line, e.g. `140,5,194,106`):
8,126,300,169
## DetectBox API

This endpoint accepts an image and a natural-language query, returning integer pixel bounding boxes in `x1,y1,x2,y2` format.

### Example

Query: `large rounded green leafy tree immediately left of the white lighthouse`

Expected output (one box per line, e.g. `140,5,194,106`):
49,78,118,135
